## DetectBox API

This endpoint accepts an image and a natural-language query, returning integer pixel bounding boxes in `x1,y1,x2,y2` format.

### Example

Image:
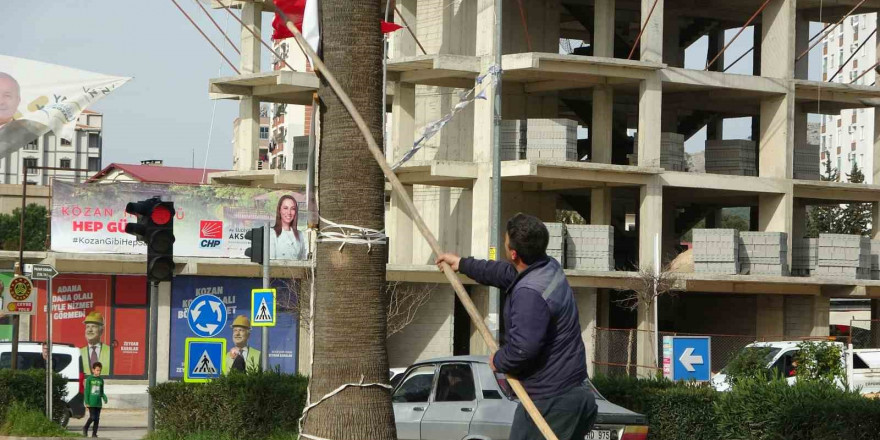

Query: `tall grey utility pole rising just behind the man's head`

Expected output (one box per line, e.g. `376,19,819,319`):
489,0,502,341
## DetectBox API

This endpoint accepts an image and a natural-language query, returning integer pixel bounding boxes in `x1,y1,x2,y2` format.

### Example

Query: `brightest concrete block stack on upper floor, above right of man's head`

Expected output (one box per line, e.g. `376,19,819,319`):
525,119,578,161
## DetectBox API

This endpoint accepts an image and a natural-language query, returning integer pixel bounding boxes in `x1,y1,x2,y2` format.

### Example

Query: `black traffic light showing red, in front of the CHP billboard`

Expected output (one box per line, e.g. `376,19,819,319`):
125,197,175,282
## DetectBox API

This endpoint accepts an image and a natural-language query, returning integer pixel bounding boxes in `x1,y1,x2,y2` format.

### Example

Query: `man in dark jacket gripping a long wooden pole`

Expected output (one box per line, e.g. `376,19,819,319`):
437,214,597,440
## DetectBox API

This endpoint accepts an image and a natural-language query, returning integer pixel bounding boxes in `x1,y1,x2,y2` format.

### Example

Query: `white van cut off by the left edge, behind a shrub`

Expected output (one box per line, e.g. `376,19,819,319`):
0,342,86,426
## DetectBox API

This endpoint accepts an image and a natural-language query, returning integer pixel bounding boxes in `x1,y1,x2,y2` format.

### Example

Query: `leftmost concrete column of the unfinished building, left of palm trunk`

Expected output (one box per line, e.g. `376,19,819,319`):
232,2,262,171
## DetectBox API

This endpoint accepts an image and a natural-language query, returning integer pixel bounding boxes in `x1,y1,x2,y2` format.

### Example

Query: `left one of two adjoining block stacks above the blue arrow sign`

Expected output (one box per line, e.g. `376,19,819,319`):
693,229,739,275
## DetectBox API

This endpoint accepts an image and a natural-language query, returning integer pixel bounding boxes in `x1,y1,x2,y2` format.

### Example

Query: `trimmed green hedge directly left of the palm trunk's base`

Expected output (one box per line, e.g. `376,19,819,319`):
150,372,308,440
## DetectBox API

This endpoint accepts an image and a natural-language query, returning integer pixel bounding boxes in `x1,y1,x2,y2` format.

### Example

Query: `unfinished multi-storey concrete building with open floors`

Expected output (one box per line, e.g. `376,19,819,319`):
211,0,880,373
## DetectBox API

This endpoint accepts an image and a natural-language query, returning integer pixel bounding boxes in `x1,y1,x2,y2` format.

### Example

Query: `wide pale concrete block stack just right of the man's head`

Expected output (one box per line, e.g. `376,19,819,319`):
565,225,614,272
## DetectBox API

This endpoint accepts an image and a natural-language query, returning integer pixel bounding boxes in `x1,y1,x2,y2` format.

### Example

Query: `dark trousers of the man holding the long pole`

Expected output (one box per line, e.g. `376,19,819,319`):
509,385,599,440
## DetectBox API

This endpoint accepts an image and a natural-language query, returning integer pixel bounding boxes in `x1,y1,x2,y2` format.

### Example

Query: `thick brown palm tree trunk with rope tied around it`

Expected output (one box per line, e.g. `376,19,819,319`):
303,0,396,440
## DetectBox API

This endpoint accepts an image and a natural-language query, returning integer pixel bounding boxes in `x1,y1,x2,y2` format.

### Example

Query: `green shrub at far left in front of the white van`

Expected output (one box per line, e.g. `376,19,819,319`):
0,369,67,422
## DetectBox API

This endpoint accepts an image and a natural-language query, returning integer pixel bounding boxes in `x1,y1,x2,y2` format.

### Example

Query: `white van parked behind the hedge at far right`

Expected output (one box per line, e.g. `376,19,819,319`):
711,341,880,395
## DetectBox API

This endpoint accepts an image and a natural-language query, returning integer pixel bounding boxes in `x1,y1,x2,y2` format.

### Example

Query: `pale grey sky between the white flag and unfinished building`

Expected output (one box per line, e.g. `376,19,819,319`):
0,0,272,169
